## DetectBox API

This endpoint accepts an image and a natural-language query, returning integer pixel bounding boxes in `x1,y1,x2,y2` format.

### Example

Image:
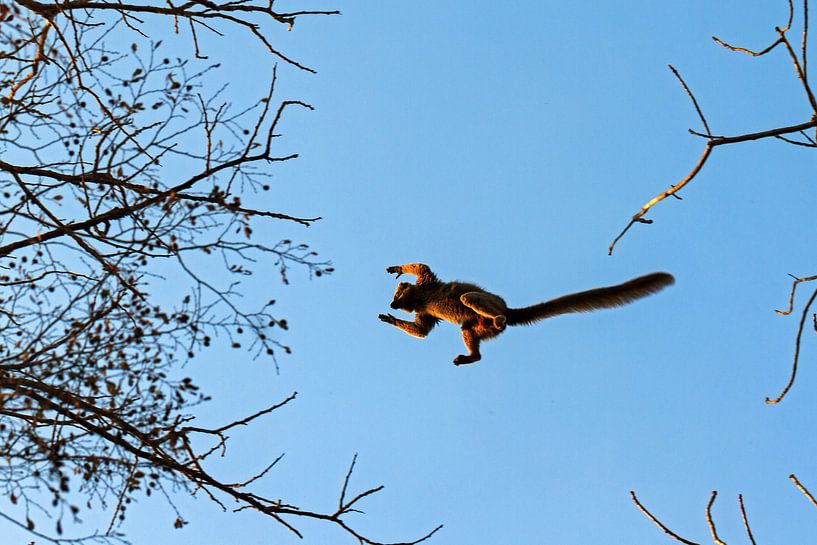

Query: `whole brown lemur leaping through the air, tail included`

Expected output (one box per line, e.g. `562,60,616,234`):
378,263,675,365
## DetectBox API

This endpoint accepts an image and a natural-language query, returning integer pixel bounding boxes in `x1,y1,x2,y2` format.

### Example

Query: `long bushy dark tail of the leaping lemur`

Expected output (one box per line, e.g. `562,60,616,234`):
505,273,675,325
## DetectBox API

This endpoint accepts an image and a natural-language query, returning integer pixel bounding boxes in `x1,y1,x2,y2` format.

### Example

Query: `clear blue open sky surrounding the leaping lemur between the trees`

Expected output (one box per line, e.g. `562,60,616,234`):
12,0,817,545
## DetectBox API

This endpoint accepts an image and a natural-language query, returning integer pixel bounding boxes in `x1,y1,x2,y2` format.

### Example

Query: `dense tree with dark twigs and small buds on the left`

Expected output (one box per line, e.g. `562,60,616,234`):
0,0,436,544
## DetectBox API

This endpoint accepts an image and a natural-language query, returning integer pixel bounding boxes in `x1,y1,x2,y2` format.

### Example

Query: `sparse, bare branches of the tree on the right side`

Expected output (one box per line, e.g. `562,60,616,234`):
608,0,817,545
